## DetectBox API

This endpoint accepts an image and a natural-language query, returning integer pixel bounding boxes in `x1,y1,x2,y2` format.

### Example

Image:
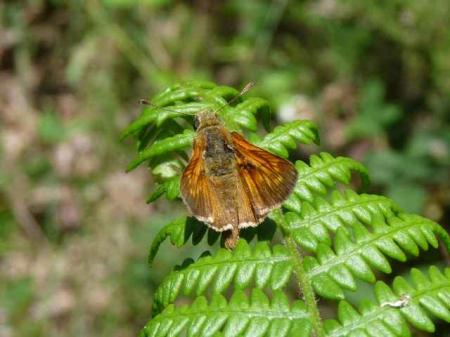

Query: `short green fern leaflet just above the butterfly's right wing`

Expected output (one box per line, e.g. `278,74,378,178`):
258,120,319,158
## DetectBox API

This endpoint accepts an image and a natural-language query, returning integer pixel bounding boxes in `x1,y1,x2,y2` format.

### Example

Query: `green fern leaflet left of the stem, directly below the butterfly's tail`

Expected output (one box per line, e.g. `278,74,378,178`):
153,239,292,312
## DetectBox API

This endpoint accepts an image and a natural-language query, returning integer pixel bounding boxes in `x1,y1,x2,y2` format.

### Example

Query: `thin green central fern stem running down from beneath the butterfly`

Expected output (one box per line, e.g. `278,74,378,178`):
272,210,325,337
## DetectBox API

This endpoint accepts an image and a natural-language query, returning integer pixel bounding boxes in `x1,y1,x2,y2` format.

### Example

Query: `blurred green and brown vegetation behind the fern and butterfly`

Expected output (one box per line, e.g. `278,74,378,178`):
0,0,450,337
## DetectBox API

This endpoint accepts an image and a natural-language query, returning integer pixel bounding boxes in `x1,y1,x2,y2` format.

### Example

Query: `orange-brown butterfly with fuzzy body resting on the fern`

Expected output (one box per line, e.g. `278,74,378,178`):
180,96,297,249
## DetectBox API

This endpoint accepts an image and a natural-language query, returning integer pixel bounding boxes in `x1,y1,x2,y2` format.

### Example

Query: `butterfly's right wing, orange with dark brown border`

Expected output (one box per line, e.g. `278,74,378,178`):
231,132,297,222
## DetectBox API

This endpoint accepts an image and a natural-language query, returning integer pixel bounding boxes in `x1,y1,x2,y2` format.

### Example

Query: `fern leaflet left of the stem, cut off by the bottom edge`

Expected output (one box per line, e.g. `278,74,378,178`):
141,289,311,337
